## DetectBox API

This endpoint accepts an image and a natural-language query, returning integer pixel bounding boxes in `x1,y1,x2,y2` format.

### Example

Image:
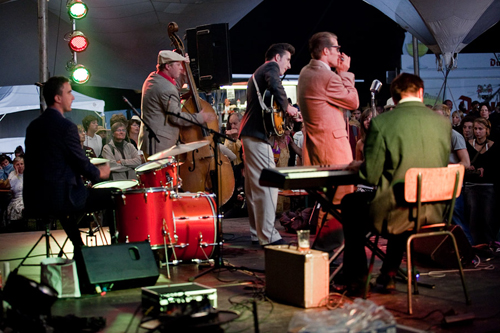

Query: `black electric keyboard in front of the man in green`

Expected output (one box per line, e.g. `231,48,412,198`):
259,165,360,190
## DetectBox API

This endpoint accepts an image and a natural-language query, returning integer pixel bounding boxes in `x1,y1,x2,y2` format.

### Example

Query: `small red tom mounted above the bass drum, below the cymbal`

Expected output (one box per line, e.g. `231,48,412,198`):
135,157,180,188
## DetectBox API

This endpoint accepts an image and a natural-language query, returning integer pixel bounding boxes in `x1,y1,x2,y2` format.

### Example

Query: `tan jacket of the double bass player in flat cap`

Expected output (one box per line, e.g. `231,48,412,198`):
139,72,203,154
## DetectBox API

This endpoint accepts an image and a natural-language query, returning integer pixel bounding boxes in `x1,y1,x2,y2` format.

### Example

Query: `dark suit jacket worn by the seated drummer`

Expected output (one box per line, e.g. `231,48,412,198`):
23,108,99,215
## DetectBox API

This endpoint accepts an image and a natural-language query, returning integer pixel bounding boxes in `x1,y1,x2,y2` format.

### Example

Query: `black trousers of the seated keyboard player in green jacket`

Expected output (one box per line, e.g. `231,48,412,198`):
342,192,410,283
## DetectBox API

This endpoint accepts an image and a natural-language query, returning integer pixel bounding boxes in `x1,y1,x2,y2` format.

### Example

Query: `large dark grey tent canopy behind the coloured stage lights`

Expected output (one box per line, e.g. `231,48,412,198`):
0,0,262,89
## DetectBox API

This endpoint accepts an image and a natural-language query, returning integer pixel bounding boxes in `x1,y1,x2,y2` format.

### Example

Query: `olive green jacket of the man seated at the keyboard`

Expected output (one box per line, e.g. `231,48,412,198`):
360,101,451,234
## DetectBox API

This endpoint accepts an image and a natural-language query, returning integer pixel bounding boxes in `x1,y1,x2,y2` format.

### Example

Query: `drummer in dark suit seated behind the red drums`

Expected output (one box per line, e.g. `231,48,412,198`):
23,77,114,290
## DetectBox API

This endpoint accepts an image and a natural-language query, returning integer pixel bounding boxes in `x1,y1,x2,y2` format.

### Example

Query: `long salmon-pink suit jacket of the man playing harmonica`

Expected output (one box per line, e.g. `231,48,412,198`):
298,59,359,202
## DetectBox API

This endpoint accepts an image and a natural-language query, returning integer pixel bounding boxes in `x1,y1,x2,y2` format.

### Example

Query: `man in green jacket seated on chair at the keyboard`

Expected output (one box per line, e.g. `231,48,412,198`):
342,73,451,294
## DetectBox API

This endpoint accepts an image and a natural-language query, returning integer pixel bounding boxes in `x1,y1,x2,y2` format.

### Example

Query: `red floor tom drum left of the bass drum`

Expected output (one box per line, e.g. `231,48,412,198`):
114,187,172,249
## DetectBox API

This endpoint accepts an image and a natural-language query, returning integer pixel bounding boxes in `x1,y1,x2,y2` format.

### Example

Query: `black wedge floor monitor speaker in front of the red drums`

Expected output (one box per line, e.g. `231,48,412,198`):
82,241,160,289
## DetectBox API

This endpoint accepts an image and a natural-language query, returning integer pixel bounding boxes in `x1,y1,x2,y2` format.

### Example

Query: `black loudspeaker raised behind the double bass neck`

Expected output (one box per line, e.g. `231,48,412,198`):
186,23,232,91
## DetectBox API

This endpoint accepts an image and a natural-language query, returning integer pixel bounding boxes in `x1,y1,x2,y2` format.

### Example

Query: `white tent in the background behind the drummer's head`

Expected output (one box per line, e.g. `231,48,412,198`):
0,85,104,152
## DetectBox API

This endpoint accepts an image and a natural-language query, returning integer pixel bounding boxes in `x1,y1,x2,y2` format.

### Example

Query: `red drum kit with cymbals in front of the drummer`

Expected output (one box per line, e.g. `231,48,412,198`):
91,140,217,265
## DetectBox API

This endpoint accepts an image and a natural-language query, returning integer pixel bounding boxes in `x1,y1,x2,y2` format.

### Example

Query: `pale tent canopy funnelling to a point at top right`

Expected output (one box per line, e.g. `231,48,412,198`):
364,0,500,68
